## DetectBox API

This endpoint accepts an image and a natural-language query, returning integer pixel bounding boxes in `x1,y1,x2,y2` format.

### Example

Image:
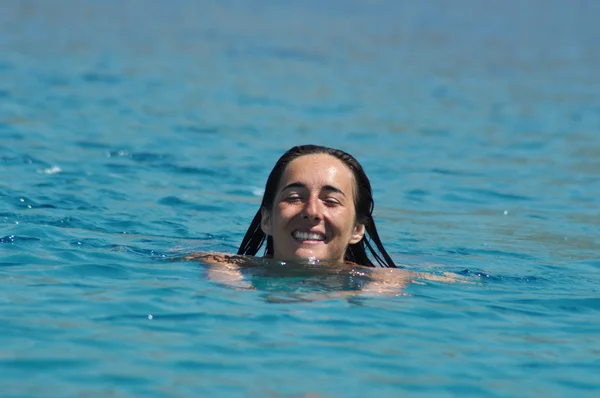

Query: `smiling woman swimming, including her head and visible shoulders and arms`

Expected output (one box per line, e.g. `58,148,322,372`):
187,145,448,293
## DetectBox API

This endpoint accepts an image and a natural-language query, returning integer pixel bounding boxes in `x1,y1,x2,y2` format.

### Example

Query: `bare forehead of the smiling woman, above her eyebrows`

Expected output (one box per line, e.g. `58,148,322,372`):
280,153,354,191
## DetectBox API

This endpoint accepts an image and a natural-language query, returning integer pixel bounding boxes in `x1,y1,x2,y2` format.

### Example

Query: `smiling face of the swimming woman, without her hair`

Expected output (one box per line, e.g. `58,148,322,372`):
261,154,365,262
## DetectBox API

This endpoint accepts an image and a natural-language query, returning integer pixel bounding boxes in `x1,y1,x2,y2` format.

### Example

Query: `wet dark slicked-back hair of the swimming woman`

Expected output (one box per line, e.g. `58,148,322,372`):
238,145,396,268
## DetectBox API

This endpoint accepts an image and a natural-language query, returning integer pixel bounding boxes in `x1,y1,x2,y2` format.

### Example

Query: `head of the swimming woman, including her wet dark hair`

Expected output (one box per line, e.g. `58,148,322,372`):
238,145,395,267
